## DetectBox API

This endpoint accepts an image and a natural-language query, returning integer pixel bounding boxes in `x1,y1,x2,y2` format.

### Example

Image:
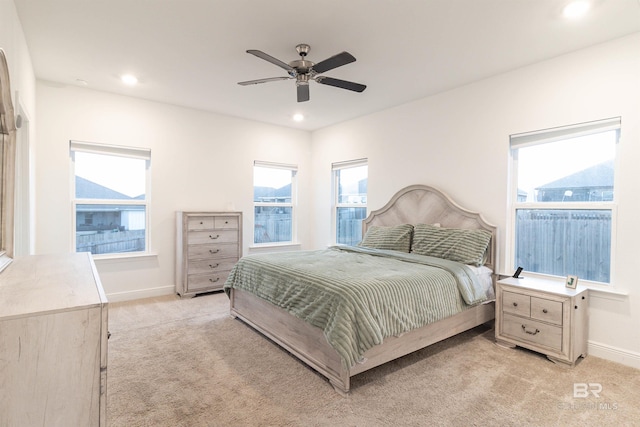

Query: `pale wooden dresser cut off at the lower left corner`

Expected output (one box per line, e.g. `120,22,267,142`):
0,253,108,427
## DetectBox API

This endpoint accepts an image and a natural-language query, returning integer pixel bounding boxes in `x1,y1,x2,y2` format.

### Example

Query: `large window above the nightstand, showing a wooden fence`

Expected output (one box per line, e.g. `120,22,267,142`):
510,118,620,283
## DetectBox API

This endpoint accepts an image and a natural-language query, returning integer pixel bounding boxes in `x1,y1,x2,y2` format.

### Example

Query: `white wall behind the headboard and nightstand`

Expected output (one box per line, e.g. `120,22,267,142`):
312,33,640,367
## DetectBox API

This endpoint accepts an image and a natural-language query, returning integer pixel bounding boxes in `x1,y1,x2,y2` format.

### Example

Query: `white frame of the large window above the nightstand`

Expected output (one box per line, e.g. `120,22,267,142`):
507,117,622,289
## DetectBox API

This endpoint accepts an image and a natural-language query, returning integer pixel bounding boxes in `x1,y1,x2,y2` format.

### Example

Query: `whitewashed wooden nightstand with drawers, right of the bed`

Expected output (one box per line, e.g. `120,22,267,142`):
496,277,589,366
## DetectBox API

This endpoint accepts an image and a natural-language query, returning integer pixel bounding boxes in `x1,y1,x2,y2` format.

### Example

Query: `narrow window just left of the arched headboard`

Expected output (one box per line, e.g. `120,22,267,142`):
332,159,368,246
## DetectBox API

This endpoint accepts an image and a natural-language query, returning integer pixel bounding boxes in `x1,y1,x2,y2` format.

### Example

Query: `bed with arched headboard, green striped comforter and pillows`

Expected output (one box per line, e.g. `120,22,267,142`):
224,185,496,394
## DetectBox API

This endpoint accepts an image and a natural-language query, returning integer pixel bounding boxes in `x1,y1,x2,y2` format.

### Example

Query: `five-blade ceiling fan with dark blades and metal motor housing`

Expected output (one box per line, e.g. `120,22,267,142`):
238,44,367,102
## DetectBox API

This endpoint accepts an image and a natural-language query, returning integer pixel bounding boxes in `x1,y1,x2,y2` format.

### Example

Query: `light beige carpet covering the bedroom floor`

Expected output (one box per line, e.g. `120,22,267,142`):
107,293,640,427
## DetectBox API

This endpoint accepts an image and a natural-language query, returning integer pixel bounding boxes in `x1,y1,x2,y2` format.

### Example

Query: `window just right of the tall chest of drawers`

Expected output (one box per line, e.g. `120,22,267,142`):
253,161,298,244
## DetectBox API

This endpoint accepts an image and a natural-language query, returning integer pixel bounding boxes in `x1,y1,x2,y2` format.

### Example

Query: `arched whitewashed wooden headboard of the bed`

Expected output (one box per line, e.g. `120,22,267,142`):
362,185,497,271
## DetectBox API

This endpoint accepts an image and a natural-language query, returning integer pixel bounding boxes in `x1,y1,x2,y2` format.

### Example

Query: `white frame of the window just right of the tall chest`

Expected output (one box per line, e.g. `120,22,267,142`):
252,160,298,248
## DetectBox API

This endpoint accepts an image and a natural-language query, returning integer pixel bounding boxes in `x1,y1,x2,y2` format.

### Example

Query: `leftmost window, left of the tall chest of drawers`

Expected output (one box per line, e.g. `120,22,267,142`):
70,141,151,255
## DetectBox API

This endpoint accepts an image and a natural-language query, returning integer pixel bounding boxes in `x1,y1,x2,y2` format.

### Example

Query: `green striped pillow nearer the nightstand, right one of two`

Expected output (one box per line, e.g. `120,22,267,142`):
411,224,491,266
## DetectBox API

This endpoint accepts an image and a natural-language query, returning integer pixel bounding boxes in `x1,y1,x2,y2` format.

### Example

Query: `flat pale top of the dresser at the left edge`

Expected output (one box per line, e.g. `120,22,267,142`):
0,252,107,319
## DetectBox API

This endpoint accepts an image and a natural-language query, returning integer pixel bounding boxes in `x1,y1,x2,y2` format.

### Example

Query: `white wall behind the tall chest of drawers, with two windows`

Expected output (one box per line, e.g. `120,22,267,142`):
36,81,312,301
